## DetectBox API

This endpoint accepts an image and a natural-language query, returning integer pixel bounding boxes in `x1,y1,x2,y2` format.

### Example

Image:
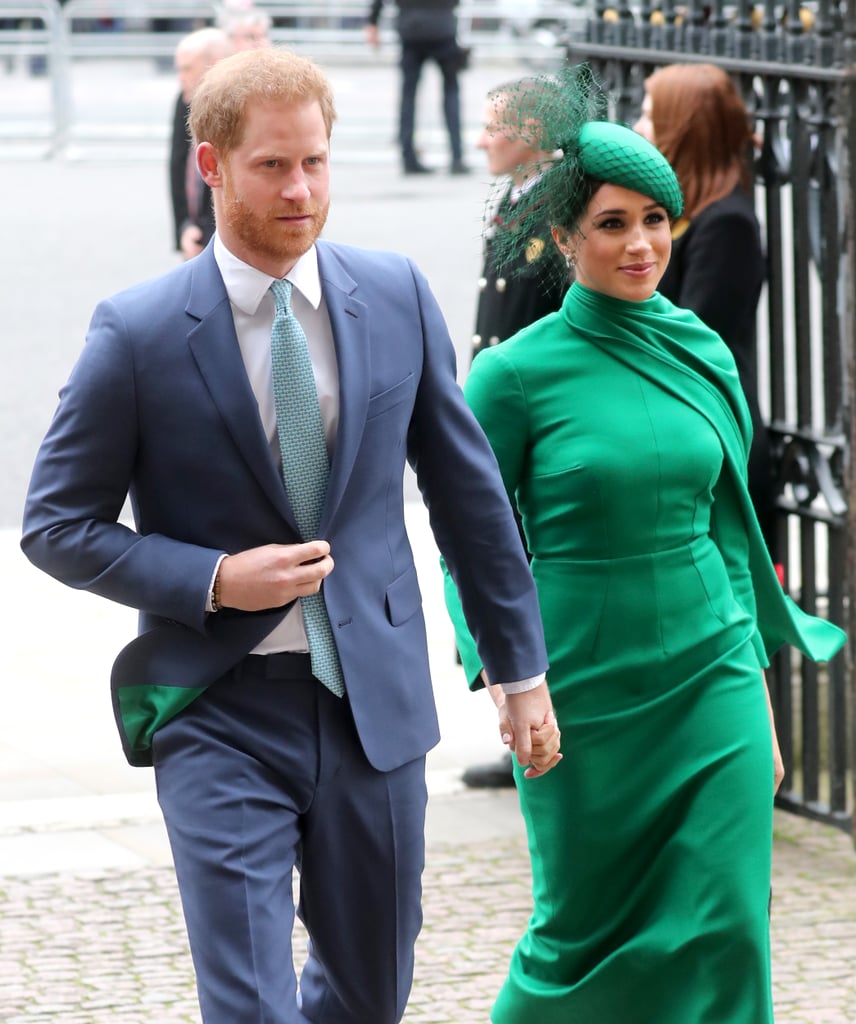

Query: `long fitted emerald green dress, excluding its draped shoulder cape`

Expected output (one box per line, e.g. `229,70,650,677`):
447,286,847,1024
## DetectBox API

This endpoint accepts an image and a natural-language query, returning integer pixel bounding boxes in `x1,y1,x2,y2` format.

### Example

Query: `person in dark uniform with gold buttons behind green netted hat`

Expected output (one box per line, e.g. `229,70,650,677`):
462,78,569,788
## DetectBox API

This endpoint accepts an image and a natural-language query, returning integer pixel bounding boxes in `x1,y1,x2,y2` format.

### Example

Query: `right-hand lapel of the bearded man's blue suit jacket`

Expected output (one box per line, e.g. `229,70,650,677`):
317,243,370,537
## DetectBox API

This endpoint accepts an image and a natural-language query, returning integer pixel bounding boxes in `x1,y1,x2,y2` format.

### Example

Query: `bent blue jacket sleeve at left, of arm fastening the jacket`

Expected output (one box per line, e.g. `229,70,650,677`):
22,300,223,631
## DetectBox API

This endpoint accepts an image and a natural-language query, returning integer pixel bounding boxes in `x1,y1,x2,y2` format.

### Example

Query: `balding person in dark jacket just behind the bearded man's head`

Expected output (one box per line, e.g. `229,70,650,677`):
169,27,233,259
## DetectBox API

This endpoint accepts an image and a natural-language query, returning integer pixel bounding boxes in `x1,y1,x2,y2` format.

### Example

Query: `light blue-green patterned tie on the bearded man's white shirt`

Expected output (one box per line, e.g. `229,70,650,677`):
270,281,345,697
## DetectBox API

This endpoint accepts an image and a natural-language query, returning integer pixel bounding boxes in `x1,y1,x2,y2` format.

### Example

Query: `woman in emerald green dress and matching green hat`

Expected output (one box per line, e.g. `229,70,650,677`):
446,81,844,1024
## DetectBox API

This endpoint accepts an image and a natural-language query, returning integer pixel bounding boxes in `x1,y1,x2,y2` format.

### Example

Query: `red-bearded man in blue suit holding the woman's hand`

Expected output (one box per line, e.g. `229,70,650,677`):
23,49,560,1024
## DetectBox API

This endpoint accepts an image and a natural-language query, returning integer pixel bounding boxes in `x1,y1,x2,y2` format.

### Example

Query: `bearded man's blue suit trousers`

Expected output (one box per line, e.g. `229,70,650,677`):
154,655,427,1024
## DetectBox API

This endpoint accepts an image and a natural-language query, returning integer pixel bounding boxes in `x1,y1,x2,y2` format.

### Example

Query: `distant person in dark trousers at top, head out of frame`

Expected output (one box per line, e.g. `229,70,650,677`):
366,0,469,174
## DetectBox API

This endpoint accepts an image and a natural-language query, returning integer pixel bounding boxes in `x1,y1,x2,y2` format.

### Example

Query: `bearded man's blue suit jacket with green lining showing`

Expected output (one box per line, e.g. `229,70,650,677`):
22,242,547,770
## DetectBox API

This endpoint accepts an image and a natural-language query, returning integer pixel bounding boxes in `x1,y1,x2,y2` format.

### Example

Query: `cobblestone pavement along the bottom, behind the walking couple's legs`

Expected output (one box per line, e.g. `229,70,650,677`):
0,793,856,1024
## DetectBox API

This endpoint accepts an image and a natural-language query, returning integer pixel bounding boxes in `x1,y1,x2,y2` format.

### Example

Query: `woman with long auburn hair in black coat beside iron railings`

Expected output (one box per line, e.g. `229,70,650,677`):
634,63,781,575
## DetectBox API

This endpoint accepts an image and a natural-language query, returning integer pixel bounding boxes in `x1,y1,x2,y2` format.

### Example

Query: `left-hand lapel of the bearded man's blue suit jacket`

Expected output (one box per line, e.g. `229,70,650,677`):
186,246,296,528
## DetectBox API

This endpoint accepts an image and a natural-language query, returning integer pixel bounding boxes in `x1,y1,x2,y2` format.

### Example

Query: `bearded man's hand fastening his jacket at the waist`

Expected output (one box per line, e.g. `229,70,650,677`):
219,541,333,611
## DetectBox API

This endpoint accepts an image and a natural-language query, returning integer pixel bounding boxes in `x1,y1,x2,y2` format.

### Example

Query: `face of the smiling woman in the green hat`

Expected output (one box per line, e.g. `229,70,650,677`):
553,184,672,302
